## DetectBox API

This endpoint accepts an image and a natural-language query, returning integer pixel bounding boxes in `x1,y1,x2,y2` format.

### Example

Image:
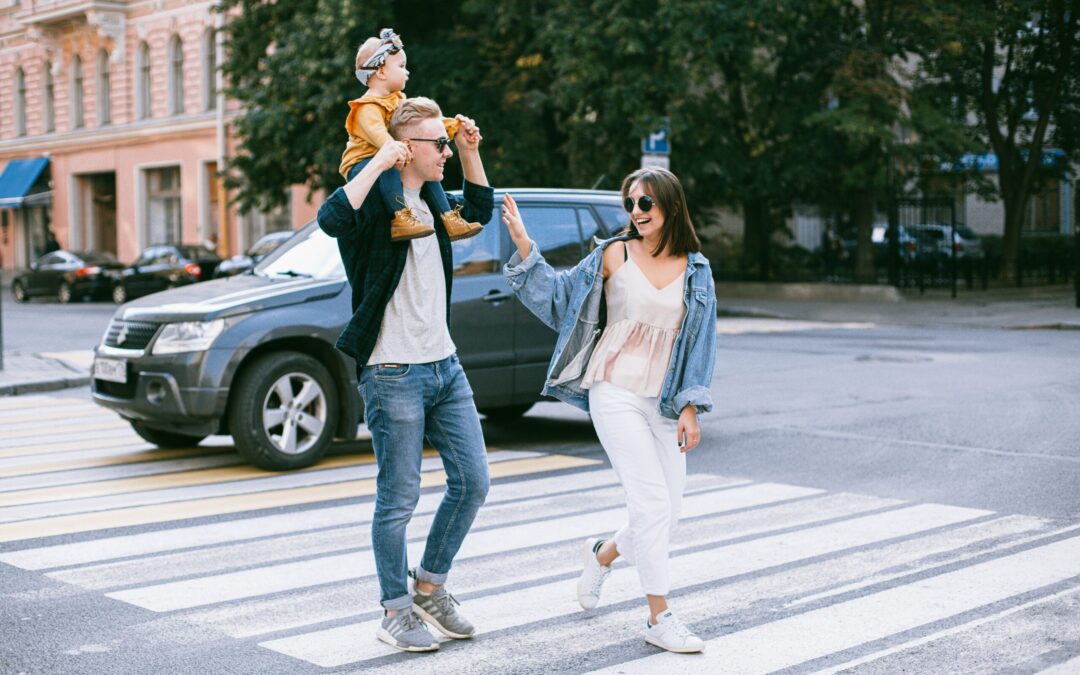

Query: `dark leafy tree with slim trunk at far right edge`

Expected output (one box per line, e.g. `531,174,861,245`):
926,0,1080,280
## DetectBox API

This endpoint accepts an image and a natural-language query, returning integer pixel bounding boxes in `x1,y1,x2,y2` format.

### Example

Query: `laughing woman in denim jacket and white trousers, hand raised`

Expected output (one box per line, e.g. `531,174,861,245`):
502,168,716,652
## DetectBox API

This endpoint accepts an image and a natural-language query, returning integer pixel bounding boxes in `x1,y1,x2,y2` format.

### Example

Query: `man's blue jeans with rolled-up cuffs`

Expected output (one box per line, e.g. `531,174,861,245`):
360,354,489,610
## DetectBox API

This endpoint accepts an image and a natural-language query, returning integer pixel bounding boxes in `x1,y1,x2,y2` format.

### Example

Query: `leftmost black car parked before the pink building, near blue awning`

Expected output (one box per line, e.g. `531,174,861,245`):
11,251,124,302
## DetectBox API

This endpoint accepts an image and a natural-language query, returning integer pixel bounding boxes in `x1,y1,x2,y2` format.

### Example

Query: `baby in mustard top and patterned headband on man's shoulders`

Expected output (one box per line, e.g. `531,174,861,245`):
339,28,484,241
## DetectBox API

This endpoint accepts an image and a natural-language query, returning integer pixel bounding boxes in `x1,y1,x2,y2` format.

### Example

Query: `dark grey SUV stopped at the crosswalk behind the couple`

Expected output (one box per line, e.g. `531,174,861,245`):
92,189,626,469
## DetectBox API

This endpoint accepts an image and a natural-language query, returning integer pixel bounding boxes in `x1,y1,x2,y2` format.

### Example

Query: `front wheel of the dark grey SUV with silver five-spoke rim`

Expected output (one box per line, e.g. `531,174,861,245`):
229,352,338,470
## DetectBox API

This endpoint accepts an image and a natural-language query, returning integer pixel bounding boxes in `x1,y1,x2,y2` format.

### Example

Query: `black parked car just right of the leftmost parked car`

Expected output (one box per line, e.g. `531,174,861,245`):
112,244,221,305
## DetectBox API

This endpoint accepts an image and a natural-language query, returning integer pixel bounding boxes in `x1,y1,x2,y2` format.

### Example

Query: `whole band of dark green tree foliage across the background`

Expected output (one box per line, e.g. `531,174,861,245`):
214,0,1080,278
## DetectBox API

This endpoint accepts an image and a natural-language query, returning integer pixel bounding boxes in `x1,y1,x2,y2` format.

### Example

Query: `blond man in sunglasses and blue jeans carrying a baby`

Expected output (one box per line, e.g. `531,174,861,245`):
319,97,494,651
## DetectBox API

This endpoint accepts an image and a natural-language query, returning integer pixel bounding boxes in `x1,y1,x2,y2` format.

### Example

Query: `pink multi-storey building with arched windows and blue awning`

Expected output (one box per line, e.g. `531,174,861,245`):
0,0,318,269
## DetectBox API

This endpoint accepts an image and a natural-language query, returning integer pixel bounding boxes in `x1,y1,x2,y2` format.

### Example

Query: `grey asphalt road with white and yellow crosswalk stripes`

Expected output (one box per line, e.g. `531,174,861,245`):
0,319,1080,674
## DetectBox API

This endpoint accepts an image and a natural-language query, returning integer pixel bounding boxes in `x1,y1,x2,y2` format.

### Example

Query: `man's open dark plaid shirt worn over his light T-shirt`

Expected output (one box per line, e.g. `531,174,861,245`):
318,180,495,369
